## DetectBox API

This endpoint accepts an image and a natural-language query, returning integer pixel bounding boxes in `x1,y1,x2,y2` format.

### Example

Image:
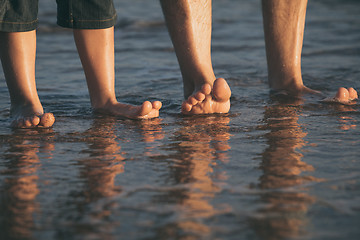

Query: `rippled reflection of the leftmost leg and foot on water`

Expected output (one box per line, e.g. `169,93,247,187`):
0,130,54,239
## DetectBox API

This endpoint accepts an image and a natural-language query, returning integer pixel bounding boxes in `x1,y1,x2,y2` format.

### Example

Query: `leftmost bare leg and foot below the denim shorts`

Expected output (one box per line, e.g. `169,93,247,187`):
0,30,55,128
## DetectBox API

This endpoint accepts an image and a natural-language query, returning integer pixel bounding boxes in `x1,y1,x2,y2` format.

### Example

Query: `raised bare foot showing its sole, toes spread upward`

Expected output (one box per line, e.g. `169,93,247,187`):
181,78,231,115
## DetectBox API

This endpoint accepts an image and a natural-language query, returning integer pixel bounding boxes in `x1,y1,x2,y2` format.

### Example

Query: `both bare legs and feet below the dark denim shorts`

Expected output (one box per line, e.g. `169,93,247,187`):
0,27,162,128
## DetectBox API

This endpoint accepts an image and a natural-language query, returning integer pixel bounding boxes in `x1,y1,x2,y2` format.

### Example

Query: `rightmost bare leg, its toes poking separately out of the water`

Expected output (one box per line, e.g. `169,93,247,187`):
262,0,356,102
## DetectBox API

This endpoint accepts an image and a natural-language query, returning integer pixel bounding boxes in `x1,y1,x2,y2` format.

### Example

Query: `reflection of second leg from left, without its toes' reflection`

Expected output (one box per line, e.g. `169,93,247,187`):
61,117,124,239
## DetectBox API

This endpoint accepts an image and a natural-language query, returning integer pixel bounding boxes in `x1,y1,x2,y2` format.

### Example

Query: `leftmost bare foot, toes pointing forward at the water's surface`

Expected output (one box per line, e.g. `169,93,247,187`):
11,109,55,128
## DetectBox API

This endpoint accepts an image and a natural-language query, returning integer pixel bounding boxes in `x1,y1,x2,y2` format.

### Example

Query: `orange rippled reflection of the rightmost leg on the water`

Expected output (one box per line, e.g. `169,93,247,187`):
251,99,322,239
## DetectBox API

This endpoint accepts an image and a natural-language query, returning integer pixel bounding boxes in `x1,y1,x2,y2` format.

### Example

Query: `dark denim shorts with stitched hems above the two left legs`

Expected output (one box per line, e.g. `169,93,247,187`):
0,0,116,32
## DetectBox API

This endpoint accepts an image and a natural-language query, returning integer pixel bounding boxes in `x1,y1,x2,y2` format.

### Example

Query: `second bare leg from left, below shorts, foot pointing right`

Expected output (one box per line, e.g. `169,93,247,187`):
74,27,161,119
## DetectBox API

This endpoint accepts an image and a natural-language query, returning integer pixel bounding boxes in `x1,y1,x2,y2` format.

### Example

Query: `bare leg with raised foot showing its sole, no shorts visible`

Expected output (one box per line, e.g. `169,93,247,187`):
160,0,231,114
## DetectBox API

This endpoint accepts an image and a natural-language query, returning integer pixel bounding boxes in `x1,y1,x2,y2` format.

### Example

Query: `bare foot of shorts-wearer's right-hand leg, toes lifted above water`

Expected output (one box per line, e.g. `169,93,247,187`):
95,101,162,119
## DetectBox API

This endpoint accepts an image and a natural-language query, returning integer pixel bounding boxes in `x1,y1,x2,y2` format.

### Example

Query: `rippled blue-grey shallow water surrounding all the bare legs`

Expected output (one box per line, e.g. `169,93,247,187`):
0,0,360,240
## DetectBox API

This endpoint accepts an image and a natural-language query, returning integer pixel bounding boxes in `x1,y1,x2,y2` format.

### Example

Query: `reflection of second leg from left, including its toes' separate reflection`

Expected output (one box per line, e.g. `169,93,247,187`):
53,116,163,239
